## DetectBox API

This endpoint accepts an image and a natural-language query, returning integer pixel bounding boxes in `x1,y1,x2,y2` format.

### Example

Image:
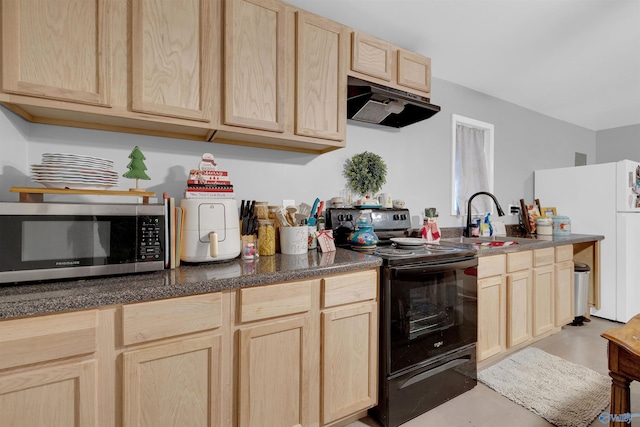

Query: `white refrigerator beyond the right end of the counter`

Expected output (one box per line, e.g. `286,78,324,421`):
534,160,640,322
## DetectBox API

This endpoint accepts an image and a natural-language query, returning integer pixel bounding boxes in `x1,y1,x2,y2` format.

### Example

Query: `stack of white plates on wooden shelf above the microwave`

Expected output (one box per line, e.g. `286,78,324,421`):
31,153,118,190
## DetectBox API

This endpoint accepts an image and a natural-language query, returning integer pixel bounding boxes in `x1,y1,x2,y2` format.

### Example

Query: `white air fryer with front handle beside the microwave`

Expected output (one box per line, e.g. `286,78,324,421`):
180,199,240,262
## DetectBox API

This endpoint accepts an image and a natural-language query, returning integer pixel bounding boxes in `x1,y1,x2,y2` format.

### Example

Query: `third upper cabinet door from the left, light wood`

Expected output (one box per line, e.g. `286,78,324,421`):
224,0,284,132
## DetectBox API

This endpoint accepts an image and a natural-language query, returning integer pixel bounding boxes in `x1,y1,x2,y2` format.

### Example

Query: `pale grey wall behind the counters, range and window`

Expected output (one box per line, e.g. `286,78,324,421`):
0,78,596,226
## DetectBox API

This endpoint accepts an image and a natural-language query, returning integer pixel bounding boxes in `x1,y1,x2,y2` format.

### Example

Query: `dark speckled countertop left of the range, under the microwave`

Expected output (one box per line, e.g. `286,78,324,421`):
0,249,382,319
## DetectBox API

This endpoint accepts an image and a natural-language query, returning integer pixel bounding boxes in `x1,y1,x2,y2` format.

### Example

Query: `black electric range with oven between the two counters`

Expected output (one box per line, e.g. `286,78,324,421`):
327,208,478,427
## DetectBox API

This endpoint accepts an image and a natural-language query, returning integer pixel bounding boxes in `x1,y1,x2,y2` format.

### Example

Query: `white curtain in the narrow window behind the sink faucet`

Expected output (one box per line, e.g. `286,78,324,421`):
456,124,491,215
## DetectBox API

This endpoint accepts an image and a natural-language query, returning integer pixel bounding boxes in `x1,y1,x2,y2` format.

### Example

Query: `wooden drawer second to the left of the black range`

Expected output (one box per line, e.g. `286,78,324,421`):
238,280,314,322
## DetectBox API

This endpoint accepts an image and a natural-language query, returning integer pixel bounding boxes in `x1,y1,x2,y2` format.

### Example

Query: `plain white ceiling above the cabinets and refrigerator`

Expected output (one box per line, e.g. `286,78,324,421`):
286,0,640,131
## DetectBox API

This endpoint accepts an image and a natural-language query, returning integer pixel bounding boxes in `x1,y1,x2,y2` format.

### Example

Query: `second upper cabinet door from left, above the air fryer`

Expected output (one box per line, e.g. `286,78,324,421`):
131,0,216,122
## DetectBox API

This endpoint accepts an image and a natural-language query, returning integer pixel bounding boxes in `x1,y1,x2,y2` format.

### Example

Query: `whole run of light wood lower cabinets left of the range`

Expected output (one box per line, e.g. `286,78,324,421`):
0,269,378,427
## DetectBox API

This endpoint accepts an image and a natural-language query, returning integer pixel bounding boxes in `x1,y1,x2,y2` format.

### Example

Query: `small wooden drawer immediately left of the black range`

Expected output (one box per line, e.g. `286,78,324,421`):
322,270,378,308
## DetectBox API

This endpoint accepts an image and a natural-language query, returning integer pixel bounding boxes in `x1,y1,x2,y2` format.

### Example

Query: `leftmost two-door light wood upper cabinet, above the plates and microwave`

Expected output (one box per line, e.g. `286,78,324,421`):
0,0,222,141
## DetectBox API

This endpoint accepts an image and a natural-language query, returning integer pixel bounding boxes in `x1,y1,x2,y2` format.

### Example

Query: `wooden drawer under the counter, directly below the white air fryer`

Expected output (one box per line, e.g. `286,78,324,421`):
122,292,222,345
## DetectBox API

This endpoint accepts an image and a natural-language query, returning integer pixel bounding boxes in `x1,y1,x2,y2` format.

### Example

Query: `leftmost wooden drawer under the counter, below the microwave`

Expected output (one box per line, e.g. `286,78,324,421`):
0,310,98,369
